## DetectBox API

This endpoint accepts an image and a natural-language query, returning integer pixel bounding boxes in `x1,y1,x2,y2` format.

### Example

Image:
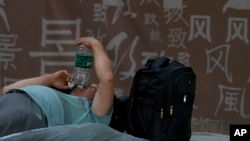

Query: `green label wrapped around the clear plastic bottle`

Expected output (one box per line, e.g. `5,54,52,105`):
75,54,93,69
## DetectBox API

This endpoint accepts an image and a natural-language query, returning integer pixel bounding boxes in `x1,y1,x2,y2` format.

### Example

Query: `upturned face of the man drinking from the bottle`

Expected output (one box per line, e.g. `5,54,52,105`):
71,84,98,101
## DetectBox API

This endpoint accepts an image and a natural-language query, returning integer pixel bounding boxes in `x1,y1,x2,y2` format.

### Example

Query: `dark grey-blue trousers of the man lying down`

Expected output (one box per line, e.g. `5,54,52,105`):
0,91,47,137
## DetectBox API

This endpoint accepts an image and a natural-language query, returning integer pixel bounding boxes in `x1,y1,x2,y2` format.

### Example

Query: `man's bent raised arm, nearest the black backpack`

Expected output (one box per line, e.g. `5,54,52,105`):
76,37,114,116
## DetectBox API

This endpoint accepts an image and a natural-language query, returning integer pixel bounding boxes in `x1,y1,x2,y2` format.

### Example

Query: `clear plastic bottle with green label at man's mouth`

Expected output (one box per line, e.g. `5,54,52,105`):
73,45,93,88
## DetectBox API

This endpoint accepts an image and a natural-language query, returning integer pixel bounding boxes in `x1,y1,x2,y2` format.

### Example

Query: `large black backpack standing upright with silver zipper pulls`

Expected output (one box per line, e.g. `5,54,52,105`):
128,57,196,141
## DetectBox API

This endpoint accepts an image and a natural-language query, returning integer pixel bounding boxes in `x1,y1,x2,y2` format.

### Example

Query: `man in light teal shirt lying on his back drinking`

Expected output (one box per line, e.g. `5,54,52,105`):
0,37,128,137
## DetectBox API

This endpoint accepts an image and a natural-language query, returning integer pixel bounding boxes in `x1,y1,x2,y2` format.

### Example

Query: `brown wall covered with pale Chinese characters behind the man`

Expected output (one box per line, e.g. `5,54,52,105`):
0,0,250,134
